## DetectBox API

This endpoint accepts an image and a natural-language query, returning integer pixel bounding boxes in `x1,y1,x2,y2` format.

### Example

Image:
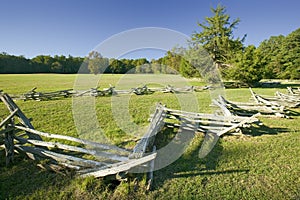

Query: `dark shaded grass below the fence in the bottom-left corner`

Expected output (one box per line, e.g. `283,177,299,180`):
0,150,71,199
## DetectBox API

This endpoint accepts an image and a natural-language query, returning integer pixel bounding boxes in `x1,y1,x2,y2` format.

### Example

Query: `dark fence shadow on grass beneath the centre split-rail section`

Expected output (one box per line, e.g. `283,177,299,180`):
152,129,249,190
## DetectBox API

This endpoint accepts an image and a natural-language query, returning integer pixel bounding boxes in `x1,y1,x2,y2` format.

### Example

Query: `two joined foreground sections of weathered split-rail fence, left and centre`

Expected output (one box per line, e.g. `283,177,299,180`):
0,93,258,187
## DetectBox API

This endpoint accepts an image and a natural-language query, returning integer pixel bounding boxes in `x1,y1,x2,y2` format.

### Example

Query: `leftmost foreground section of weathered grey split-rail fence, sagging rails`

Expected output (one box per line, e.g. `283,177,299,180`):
0,93,156,177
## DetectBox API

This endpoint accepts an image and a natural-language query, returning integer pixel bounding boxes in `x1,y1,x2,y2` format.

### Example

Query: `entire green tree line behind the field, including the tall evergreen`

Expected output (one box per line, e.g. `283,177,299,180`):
0,5,300,85
